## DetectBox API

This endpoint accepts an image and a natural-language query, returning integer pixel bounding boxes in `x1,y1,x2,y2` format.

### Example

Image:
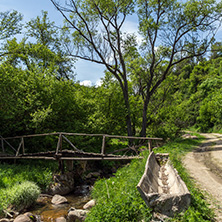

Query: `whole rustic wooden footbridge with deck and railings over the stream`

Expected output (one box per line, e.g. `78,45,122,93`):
0,132,162,161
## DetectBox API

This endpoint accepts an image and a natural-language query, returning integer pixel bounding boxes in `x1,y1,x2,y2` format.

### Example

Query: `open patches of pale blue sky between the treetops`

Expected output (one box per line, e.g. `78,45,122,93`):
0,0,137,85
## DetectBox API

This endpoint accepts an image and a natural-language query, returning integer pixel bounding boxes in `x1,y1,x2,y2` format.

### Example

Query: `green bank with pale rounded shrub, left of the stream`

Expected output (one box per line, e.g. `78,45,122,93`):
0,161,53,215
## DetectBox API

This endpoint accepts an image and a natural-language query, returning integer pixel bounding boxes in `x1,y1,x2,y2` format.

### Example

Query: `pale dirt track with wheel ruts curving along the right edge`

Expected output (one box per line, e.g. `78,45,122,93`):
184,133,222,221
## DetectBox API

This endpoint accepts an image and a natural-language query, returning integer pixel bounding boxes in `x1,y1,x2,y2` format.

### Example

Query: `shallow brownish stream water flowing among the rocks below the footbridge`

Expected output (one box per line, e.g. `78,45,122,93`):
30,187,91,222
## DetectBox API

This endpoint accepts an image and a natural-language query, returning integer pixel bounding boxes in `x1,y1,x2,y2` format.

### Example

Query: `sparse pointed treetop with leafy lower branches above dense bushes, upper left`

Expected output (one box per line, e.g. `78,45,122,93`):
2,11,74,79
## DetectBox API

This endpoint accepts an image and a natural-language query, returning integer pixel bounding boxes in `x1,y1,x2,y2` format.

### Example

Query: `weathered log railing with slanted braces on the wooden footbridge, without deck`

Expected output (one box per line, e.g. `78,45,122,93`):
0,132,163,156
